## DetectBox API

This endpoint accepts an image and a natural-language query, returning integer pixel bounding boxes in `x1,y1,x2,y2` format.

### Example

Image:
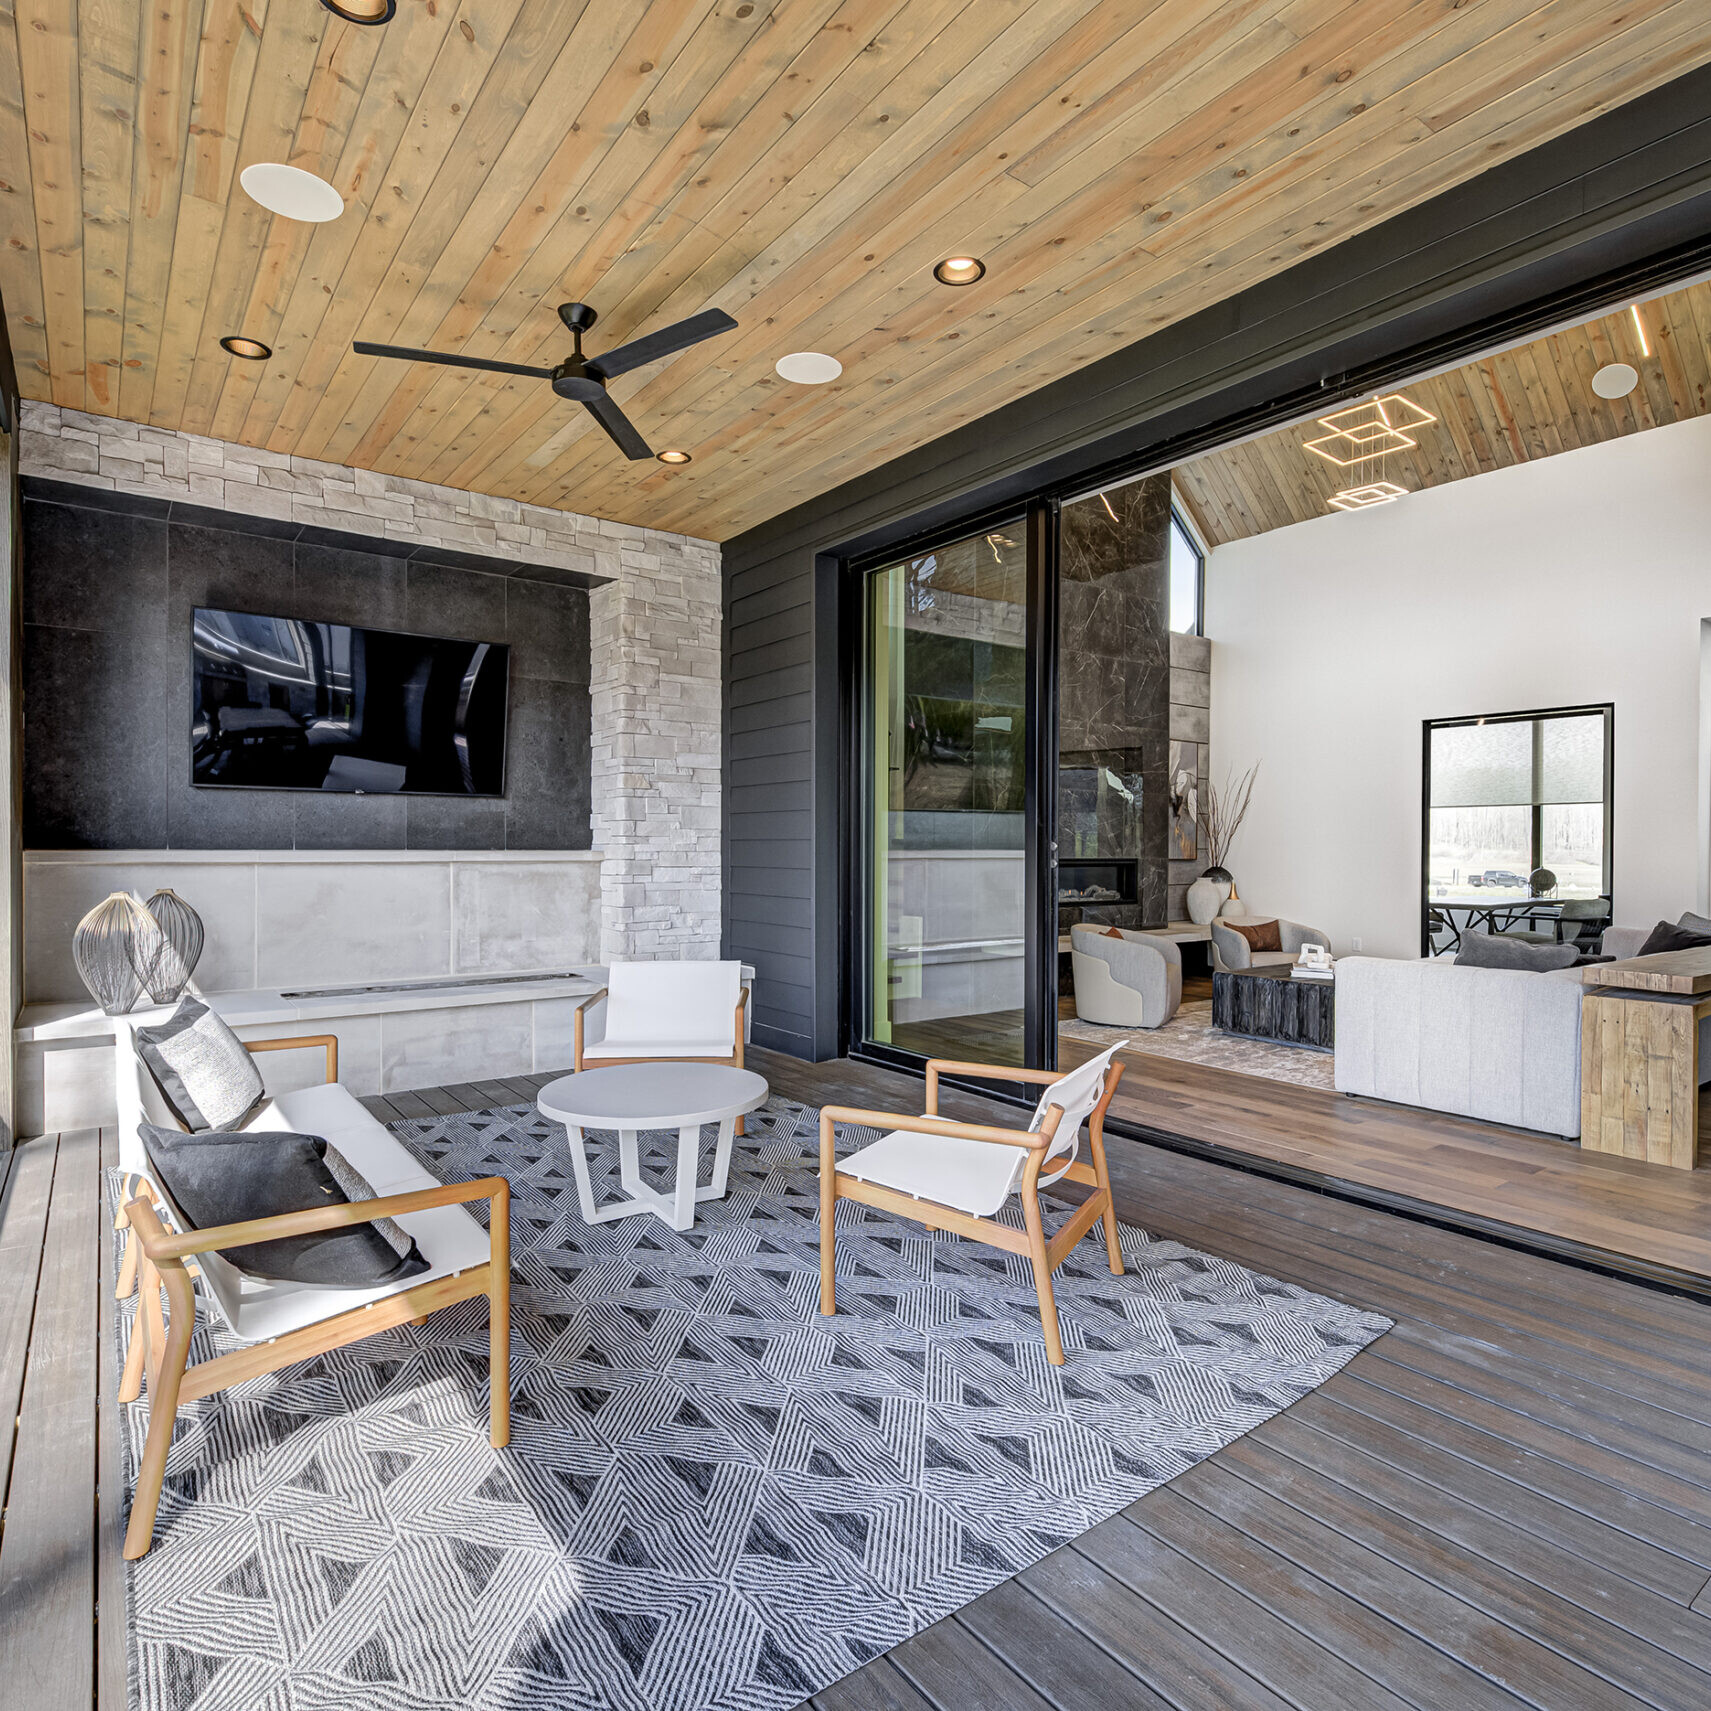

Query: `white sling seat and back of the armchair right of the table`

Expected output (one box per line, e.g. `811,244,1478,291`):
838,1040,1129,1218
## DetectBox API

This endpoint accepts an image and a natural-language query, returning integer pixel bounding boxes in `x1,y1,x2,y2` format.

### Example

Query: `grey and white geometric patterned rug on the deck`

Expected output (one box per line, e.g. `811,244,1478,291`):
121,1098,1389,1711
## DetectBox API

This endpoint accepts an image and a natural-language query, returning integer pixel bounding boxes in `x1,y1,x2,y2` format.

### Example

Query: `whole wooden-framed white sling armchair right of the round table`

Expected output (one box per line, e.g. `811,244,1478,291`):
820,1040,1129,1367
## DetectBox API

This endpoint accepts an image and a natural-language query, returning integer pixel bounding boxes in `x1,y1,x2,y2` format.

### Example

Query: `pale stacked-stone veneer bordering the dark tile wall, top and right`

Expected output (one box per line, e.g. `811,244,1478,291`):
21,402,722,958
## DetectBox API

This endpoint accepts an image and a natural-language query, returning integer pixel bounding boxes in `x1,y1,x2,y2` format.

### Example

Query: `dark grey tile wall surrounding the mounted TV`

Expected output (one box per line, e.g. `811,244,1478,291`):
22,500,590,849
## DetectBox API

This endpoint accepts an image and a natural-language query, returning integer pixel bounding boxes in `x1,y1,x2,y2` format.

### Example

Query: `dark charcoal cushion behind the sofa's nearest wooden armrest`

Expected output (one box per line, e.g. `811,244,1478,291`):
140,1122,428,1288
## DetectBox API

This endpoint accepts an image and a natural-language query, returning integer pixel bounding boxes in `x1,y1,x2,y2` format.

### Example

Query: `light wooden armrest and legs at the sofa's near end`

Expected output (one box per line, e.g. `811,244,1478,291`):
118,1177,512,1559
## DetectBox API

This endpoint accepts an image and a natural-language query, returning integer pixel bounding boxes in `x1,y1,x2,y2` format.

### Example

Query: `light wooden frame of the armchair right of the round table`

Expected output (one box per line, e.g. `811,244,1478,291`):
820,1057,1122,1367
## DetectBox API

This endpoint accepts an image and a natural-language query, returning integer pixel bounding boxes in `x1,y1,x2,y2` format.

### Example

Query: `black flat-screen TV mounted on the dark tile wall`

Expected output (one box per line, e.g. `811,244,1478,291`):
190,606,510,796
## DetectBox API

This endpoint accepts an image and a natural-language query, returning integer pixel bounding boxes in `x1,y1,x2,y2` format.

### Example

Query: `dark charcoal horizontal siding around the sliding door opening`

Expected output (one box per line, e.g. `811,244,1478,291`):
724,68,1711,1057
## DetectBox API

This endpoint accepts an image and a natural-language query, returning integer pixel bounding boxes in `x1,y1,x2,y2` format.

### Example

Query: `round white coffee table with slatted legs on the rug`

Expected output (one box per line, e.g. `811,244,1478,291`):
536,1063,767,1230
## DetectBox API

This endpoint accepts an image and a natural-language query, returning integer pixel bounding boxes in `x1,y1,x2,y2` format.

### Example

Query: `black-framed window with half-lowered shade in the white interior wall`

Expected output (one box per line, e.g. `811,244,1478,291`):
1420,703,1615,953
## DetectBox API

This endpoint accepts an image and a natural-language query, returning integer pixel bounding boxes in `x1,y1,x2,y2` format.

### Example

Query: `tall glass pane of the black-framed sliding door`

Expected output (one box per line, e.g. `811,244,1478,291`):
862,518,1030,1064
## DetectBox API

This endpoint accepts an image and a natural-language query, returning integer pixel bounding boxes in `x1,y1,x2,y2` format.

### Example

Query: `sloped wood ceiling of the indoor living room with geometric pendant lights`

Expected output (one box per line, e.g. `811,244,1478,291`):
1172,282,1711,546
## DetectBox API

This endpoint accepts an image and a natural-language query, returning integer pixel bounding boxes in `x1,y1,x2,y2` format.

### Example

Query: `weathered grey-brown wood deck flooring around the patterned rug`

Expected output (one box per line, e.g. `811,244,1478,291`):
10,1052,1711,1711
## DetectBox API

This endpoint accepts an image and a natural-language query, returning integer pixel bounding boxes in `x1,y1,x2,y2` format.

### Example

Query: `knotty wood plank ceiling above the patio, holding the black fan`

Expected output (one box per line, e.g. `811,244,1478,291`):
0,0,1711,539
